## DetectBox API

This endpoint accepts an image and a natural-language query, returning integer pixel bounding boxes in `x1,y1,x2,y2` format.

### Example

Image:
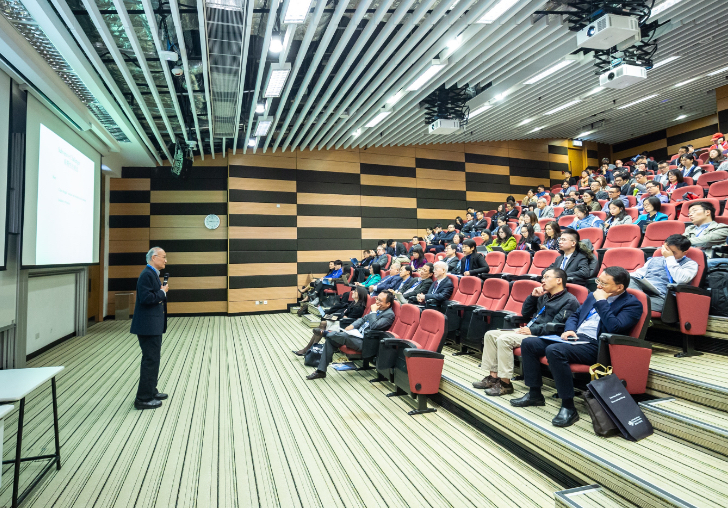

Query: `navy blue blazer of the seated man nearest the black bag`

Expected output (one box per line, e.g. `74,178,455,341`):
564,291,642,337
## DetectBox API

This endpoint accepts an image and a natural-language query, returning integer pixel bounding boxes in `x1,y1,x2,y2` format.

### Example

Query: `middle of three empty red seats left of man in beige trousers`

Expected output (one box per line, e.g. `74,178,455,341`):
458,279,510,354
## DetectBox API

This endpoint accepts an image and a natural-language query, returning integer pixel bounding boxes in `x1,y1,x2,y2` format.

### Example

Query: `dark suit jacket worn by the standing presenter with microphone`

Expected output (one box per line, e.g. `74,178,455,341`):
131,266,167,335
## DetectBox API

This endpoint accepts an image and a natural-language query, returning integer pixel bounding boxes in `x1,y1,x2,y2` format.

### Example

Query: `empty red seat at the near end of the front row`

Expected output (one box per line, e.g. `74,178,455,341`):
384,309,447,415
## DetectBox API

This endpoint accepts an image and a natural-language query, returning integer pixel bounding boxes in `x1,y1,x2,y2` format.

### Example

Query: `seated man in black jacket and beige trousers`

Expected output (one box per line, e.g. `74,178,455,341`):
473,268,579,396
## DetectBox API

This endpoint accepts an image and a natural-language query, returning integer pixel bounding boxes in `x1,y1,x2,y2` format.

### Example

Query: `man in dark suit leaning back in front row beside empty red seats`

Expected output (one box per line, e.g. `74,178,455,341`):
306,292,394,380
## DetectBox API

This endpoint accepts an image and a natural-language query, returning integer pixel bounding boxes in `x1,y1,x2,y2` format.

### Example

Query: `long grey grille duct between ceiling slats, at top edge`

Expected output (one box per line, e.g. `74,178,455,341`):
206,0,245,137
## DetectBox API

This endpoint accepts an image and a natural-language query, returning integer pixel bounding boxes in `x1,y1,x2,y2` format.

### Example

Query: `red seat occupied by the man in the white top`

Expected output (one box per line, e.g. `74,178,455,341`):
652,247,710,358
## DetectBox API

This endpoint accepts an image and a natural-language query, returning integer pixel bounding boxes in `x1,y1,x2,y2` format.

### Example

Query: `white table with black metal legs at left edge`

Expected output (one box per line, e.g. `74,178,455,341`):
0,367,64,508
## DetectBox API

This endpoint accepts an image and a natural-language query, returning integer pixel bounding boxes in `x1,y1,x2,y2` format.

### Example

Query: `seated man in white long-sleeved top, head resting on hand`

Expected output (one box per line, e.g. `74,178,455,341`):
629,235,698,312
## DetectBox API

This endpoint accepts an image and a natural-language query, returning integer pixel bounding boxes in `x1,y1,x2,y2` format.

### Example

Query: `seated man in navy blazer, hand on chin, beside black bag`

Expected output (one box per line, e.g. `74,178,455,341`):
511,266,643,427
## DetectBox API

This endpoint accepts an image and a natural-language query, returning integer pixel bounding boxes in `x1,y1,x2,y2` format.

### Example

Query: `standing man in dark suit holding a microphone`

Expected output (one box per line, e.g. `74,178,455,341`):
131,247,169,409
